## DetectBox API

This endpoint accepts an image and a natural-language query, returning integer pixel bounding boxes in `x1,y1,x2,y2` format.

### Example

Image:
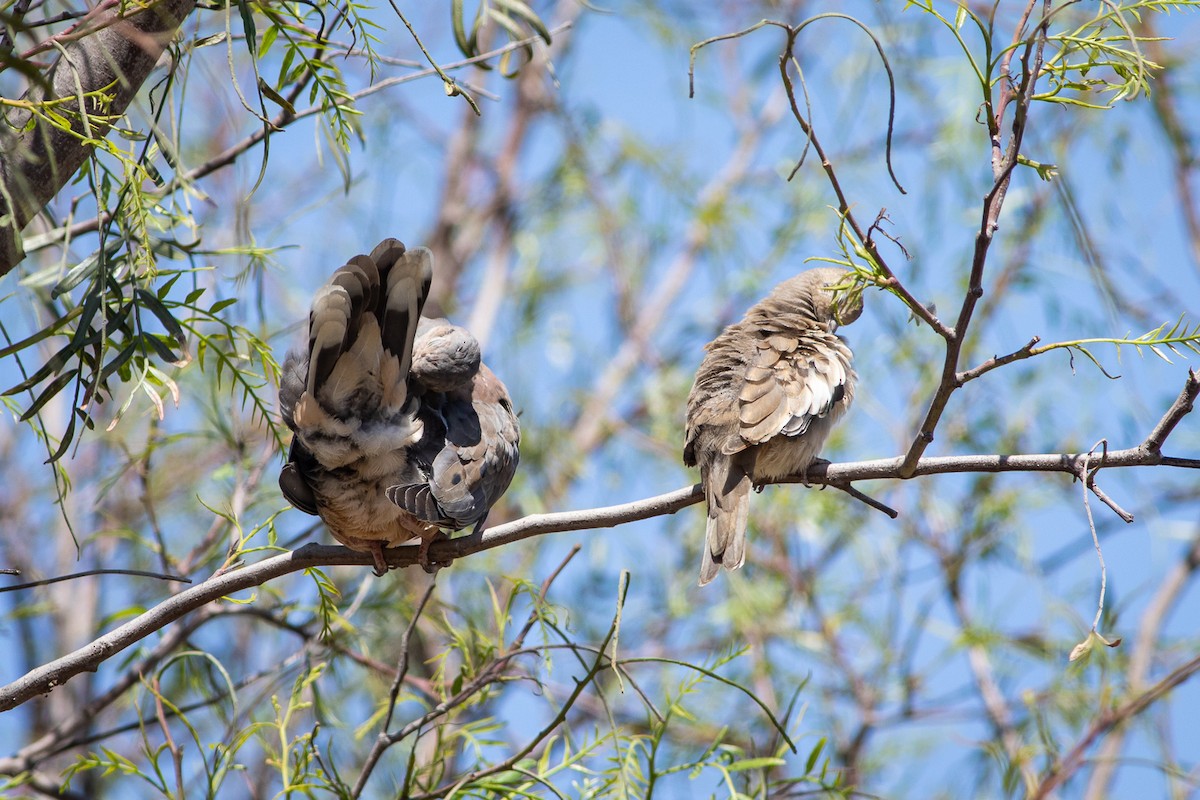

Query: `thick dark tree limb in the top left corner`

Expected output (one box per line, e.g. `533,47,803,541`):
0,0,196,275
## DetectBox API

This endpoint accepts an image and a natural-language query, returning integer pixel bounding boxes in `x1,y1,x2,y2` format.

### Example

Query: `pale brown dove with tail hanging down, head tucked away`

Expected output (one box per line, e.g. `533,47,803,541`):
683,267,863,585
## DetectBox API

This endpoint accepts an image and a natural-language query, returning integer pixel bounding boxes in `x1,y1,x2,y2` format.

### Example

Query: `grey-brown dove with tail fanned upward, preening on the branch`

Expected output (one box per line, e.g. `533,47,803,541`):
280,239,521,575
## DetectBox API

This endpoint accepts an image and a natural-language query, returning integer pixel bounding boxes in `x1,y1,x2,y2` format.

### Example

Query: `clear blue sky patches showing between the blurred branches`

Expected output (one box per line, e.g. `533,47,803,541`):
0,2,1200,796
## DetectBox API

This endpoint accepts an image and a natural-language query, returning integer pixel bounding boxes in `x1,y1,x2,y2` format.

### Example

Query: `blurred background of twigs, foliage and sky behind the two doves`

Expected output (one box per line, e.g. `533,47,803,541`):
0,0,1200,798
